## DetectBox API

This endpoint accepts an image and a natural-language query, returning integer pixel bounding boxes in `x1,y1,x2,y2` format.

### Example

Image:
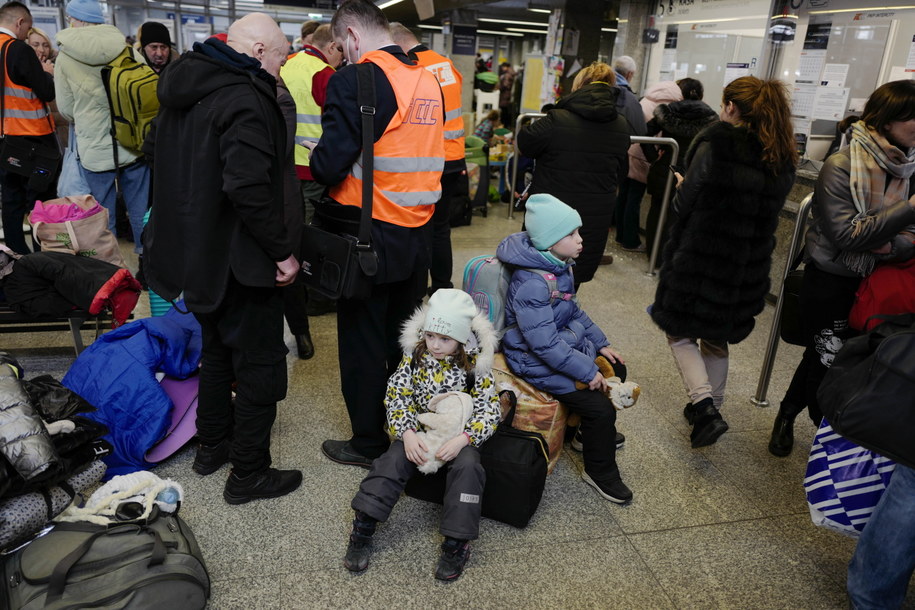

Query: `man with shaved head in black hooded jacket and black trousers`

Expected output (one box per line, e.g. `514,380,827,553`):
145,13,302,504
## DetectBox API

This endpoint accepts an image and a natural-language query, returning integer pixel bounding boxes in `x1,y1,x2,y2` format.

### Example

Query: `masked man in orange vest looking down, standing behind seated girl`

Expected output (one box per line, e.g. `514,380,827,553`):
311,0,445,468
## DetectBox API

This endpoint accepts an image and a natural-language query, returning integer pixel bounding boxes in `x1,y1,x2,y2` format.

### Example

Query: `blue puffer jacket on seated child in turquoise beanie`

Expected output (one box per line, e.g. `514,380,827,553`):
496,232,610,394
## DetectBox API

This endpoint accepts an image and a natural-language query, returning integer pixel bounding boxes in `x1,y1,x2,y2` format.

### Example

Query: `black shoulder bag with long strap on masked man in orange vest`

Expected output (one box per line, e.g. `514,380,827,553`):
299,64,378,299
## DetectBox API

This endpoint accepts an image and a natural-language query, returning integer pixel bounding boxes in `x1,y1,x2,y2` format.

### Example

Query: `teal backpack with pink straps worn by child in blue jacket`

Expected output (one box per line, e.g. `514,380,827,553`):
461,254,575,336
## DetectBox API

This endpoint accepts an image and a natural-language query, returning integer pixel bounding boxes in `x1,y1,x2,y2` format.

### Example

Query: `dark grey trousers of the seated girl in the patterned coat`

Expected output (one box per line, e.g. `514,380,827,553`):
352,441,486,540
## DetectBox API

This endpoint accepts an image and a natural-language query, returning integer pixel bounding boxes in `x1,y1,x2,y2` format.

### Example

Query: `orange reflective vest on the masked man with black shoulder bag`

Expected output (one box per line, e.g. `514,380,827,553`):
330,51,445,227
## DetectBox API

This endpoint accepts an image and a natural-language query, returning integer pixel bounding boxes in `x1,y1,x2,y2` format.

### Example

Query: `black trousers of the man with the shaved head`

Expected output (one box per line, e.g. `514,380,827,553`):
194,278,288,476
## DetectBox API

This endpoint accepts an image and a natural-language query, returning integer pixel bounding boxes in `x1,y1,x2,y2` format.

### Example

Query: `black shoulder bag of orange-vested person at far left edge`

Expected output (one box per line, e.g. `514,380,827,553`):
0,40,62,193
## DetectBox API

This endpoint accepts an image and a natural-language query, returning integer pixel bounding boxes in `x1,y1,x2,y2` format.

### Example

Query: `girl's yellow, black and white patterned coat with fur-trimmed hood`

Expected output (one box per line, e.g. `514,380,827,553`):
384,304,502,447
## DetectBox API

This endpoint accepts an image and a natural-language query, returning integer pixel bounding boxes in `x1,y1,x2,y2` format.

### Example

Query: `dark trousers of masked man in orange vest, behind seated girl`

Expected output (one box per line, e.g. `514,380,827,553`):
337,269,426,458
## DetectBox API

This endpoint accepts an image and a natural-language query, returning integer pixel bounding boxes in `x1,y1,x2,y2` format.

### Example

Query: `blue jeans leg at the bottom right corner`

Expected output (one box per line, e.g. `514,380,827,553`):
848,464,915,610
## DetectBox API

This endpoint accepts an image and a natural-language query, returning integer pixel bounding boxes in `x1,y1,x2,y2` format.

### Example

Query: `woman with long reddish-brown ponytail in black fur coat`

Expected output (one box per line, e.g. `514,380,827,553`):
650,76,797,448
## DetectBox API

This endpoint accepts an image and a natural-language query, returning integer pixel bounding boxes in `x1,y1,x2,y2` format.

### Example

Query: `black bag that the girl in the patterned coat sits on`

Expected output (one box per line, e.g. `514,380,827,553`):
404,390,549,528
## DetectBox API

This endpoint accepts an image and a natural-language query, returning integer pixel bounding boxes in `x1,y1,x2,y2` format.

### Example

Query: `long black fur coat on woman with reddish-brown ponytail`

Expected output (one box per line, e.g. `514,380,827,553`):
651,123,794,343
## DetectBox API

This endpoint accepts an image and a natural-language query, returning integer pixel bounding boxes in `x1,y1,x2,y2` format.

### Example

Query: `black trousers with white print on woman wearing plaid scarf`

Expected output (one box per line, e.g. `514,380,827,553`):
783,263,861,426
